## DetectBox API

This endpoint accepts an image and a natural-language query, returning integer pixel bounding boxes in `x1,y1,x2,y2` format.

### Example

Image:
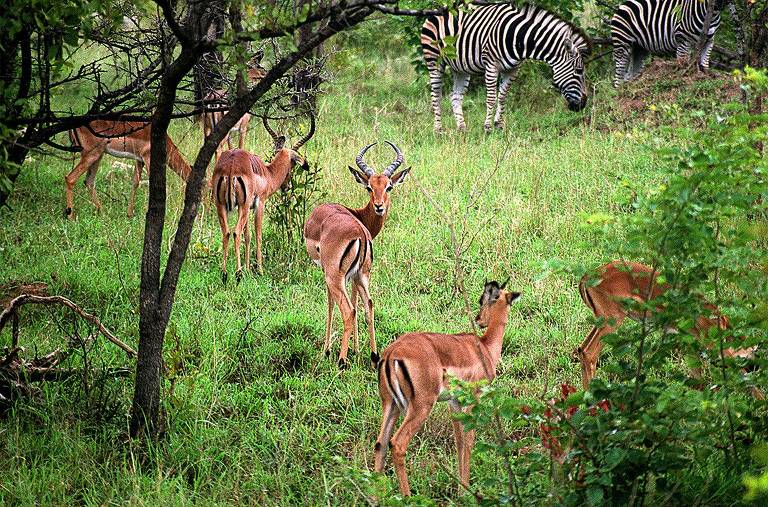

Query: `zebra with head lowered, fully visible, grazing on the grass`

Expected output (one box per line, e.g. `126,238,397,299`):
421,3,590,131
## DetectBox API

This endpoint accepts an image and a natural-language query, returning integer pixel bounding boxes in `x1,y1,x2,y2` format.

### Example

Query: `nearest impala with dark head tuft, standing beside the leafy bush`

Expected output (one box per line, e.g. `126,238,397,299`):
374,282,520,495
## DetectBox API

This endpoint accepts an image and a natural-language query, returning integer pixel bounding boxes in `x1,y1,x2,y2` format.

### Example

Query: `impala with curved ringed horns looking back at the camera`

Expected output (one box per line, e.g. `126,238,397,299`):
304,141,411,367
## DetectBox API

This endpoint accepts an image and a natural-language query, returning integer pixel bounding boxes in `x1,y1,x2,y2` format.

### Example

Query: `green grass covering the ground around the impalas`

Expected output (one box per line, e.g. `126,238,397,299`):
0,45,736,505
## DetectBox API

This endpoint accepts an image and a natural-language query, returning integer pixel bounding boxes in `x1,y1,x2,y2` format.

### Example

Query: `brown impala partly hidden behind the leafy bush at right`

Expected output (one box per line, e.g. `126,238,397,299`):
574,260,763,399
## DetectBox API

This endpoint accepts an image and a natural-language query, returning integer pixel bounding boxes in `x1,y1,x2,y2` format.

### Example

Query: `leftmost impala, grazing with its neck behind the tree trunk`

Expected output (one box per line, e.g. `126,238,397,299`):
64,120,191,218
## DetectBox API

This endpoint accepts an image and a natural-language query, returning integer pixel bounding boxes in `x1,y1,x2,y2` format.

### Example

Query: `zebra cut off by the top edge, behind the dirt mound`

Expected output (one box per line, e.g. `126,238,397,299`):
611,0,723,86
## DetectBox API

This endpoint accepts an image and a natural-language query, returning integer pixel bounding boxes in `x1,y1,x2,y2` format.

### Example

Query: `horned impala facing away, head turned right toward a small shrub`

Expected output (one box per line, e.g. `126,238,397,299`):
211,113,315,283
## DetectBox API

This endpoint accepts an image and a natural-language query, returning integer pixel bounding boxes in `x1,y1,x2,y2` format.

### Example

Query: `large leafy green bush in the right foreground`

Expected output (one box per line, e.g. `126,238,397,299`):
458,69,768,505
